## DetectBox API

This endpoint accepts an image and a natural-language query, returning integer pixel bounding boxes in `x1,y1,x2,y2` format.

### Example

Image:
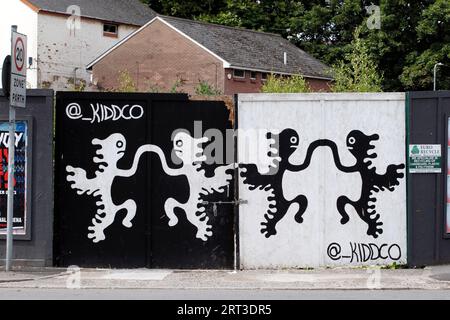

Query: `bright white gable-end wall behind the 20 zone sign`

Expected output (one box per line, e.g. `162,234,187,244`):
0,0,38,88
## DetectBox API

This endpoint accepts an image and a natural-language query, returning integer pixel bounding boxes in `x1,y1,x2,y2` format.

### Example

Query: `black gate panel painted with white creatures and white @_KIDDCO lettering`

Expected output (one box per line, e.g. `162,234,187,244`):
54,92,234,268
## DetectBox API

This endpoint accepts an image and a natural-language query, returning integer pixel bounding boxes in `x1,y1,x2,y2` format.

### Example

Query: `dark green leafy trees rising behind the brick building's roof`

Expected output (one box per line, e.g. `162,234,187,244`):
142,0,450,91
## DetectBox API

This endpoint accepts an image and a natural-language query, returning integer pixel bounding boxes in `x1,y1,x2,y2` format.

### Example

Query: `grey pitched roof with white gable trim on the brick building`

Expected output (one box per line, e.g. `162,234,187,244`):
87,16,332,79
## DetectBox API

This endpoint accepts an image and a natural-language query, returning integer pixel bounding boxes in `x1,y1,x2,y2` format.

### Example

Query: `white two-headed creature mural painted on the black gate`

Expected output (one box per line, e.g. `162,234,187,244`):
66,132,235,243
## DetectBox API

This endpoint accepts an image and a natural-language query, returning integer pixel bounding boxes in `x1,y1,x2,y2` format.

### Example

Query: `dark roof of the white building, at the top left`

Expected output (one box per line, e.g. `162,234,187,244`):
22,0,156,26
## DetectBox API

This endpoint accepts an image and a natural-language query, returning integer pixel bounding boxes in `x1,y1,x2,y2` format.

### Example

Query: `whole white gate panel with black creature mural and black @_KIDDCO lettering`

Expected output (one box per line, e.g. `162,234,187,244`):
238,93,407,268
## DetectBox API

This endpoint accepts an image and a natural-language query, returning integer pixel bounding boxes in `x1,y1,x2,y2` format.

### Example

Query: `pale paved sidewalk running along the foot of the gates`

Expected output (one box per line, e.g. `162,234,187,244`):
0,266,450,290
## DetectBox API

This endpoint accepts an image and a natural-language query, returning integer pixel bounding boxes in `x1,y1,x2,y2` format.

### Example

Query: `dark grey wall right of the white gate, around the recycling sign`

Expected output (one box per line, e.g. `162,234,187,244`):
407,91,450,266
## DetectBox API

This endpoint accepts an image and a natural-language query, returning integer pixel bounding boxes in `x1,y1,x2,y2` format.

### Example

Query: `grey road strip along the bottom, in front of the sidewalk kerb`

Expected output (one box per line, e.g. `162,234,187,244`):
0,288,450,300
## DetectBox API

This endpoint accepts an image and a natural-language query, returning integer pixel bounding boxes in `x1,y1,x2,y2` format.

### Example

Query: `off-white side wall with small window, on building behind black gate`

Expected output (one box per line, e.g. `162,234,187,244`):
38,13,137,90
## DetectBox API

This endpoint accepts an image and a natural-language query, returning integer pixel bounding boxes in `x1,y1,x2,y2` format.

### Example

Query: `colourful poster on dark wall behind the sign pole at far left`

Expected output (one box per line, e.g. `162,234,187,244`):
0,121,27,235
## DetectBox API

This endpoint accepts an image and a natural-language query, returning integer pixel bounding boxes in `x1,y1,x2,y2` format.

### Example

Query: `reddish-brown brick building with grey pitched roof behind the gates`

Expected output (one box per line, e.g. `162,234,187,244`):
87,16,332,95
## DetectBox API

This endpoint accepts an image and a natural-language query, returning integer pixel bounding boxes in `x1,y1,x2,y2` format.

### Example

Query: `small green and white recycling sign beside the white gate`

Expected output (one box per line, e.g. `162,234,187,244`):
409,144,442,173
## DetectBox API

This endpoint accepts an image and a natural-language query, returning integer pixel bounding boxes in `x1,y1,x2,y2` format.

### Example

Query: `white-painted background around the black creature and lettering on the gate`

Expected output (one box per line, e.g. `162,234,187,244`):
239,93,407,268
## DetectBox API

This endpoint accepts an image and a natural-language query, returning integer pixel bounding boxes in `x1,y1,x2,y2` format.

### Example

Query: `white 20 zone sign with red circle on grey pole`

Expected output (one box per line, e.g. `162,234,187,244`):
10,32,28,108
